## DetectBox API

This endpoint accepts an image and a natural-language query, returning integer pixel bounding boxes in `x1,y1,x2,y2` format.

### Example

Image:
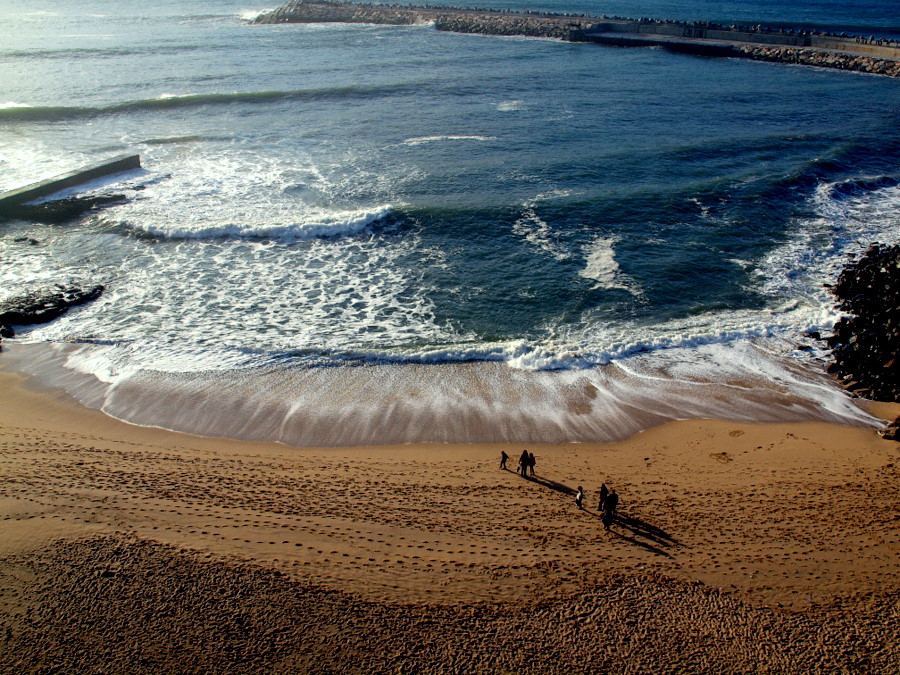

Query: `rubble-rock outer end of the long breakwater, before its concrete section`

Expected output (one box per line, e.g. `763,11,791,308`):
254,0,596,40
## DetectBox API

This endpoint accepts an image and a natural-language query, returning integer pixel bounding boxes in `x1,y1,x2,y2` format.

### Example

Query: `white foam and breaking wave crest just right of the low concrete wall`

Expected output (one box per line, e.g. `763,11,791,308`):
107,145,405,241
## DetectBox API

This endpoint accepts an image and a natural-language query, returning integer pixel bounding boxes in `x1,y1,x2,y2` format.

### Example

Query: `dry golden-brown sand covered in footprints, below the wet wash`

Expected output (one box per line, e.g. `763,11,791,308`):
0,373,900,673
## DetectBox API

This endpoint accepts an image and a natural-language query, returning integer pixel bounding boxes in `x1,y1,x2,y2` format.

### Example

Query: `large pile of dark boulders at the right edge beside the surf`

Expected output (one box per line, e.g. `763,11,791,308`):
827,244,900,402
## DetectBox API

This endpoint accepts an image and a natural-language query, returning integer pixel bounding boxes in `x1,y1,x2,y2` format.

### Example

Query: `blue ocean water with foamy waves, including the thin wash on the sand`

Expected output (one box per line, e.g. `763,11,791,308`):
0,0,900,445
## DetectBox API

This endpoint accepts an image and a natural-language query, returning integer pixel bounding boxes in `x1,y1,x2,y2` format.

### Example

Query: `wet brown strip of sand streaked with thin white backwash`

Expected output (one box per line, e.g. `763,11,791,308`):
0,342,878,447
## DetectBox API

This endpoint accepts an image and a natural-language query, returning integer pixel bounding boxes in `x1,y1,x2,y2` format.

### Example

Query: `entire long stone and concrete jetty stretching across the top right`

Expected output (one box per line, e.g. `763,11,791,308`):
254,0,900,77
